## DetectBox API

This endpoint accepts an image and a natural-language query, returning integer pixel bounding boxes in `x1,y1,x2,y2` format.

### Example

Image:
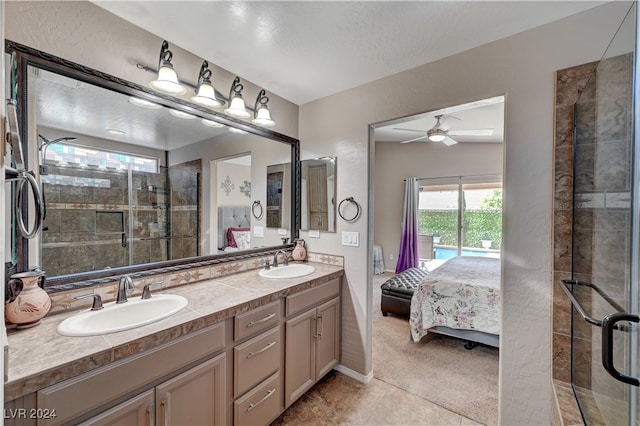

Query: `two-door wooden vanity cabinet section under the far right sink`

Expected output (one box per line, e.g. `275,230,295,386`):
284,280,340,408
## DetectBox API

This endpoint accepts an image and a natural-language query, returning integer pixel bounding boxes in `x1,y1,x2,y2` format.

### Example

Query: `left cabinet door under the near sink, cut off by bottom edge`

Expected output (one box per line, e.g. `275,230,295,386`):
79,390,155,426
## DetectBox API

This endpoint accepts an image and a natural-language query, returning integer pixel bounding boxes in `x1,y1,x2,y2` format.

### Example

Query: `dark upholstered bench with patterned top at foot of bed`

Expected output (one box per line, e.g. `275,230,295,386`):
380,268,429,317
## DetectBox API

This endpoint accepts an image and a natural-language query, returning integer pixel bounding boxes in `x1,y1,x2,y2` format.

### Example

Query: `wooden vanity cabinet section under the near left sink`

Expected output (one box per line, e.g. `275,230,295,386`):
37,322,230,426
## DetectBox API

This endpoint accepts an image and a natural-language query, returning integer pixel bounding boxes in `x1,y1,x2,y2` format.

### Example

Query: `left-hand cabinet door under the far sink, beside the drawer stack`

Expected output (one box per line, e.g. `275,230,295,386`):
284,308,316,407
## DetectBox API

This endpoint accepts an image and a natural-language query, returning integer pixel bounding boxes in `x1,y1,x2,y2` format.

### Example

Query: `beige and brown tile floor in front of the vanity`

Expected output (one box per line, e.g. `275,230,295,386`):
271,371,479,426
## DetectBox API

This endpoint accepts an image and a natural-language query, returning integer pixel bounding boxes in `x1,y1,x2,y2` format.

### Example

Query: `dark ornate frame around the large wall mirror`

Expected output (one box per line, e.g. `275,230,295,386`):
5,40,301,291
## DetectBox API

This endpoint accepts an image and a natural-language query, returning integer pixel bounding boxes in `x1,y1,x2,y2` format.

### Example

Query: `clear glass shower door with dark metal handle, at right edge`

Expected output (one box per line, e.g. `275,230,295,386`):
559,4,640,425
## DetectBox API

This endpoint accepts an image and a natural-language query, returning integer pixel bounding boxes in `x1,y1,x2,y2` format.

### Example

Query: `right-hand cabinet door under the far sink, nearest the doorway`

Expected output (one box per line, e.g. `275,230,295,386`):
315,297,340,380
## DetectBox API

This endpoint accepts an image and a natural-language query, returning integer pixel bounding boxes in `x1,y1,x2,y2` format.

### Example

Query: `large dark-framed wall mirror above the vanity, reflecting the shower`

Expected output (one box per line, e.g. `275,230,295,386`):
6,41,300,286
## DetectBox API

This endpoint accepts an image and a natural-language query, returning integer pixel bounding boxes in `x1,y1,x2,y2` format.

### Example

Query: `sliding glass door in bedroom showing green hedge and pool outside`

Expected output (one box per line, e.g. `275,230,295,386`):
418,175,502,267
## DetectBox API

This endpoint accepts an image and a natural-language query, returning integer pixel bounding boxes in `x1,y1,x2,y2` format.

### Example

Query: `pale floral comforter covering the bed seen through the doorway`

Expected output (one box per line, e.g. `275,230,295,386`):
409,256,500,342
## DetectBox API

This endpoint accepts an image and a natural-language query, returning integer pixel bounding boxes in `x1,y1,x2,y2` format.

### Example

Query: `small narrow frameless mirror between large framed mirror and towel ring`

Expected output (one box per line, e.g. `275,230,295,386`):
300,157,338,232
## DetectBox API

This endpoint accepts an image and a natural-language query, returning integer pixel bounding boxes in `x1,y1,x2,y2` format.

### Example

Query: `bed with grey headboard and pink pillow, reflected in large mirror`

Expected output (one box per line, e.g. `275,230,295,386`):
218,206,251,252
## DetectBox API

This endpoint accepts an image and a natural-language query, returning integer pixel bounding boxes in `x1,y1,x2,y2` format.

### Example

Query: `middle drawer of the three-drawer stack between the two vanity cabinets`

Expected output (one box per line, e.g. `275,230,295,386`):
233,327,282,398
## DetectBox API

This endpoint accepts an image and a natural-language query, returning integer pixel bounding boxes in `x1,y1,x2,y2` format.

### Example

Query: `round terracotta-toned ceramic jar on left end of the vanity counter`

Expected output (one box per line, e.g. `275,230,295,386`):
4,270,51,328
